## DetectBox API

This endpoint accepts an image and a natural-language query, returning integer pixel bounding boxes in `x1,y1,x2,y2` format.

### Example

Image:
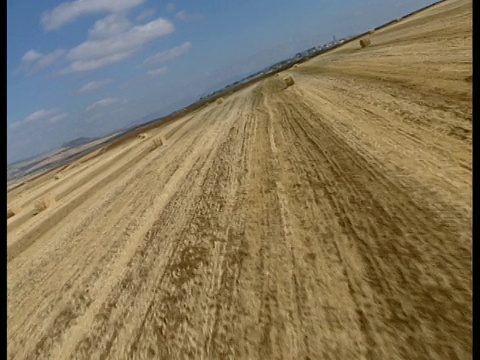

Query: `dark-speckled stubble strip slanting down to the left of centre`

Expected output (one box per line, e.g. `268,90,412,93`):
120,99,253,358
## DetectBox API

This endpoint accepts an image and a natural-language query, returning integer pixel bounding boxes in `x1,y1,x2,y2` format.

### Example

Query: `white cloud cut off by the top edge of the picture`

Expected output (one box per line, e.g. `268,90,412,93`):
41,0,144,31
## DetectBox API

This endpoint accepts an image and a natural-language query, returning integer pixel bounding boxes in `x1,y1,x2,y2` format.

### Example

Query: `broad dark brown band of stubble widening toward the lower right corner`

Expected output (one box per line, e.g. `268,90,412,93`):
272,90,471,357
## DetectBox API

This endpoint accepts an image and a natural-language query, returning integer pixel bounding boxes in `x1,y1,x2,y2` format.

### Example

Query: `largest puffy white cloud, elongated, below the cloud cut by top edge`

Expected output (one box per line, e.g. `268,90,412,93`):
60,18,174,74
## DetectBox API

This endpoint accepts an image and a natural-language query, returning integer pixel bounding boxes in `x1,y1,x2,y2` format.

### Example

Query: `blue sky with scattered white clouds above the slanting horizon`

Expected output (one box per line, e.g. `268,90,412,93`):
7,0,435,163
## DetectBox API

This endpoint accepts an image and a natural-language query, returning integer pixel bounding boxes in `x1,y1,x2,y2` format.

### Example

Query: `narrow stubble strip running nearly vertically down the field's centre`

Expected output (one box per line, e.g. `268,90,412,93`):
222,93,308,358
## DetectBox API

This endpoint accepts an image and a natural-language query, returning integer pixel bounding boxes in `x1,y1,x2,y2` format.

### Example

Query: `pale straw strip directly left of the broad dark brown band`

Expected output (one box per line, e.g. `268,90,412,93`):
262,89,372,359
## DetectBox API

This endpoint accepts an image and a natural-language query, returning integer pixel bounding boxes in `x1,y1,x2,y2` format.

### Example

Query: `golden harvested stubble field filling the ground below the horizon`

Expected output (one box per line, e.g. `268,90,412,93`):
7,0,472,360
